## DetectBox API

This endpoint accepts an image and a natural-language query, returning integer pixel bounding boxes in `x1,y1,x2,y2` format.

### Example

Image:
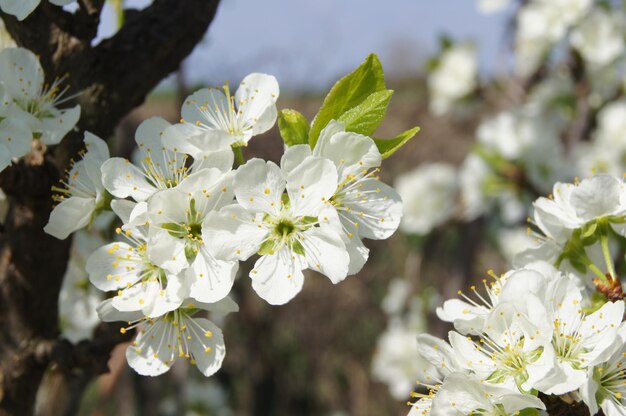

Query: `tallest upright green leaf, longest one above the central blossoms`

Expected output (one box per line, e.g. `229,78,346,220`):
309,54,385,147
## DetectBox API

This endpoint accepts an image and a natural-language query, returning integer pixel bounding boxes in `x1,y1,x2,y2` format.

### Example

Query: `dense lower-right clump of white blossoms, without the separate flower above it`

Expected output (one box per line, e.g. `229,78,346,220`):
410,261,626,415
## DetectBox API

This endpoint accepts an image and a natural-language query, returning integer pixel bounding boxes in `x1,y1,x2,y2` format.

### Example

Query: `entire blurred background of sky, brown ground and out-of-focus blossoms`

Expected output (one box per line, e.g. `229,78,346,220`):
34,0,626,416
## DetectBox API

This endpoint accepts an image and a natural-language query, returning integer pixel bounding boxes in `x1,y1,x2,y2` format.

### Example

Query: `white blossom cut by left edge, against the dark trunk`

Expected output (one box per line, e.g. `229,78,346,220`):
0,46,80,171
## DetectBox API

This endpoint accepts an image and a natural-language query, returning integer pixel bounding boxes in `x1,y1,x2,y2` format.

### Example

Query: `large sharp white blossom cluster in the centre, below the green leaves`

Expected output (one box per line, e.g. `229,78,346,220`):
45,73,402,376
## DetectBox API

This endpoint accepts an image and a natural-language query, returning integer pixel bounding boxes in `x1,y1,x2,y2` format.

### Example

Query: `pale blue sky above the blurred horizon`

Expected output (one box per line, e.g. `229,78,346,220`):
103,0,506,90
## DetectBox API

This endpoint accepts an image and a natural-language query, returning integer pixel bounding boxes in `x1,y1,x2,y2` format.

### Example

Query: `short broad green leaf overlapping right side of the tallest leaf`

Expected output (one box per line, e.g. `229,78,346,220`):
339,90,393,136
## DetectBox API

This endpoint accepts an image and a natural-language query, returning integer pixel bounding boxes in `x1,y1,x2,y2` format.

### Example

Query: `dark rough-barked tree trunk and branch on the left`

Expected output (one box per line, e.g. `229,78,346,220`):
0,0,219,416
